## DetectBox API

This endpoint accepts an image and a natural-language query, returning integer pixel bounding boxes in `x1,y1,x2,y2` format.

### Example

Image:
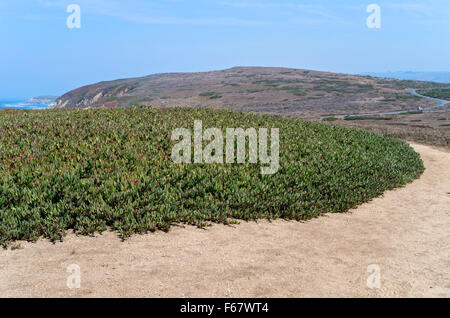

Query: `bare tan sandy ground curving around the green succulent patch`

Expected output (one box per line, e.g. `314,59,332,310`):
0,145,450,297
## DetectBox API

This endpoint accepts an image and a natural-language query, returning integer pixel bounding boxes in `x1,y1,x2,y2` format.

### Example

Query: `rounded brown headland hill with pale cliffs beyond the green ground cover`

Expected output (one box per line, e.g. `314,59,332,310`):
51,67,450,119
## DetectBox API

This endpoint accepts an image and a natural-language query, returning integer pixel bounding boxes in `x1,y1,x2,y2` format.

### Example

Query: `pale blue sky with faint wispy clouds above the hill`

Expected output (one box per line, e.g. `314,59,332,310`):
0,0,450,99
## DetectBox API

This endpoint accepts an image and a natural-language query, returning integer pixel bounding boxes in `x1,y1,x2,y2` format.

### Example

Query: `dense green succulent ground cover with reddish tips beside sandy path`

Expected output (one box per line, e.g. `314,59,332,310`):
0,107,424,246
